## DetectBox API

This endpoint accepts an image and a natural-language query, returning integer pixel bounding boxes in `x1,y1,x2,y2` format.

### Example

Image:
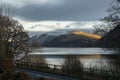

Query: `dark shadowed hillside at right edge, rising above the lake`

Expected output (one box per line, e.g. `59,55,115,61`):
99,26,120,47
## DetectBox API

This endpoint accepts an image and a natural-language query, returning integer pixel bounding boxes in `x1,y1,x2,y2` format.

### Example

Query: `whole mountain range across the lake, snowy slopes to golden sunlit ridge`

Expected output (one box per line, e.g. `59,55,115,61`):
31,31,101,47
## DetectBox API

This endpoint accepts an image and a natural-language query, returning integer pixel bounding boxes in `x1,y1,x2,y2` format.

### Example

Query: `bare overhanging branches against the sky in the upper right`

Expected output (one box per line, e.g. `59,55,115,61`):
94,0,120,35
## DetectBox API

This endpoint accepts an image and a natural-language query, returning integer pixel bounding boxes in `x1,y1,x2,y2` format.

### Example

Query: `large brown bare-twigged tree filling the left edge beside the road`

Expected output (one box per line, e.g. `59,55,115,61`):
0,4,29,80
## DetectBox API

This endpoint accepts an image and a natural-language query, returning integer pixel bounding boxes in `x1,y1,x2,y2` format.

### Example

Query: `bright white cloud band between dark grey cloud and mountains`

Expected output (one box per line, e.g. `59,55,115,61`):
19,20,101,31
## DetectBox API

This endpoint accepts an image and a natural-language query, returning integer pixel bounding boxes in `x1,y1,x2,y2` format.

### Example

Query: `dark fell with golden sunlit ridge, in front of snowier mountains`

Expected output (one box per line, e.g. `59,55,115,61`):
42,31,101,47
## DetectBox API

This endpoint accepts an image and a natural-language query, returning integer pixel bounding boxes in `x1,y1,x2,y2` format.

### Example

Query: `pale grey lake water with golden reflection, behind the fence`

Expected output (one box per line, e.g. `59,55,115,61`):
31,48,110,67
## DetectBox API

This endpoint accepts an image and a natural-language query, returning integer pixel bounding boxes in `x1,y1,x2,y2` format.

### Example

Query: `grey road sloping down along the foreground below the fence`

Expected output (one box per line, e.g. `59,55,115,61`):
16,68,80,80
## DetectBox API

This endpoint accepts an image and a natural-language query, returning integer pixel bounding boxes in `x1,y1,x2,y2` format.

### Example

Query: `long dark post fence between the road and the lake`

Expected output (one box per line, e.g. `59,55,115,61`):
16,61,120,80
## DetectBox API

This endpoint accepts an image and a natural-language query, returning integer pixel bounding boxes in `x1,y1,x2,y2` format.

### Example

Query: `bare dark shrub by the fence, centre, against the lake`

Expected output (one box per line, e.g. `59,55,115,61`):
62,55,83,75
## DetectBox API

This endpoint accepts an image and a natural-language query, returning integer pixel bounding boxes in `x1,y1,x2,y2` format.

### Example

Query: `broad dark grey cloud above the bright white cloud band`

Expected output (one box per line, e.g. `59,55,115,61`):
6,0,112,21
